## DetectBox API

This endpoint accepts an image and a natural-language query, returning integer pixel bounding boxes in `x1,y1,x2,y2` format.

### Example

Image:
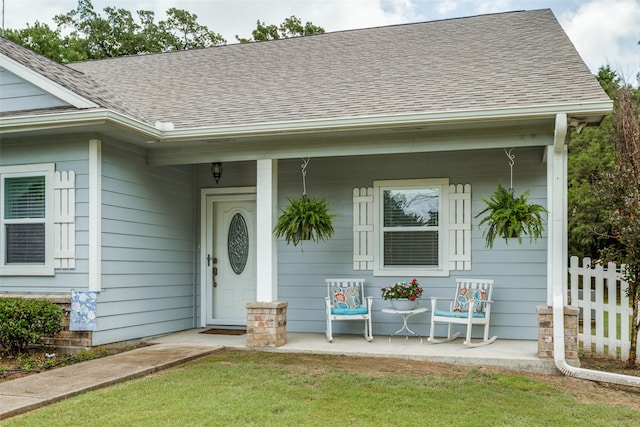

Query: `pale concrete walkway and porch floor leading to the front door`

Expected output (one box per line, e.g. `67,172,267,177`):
0,329,557,419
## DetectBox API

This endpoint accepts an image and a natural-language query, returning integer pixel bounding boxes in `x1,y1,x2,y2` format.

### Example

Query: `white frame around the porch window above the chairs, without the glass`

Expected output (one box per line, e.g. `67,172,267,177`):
373,178,449,277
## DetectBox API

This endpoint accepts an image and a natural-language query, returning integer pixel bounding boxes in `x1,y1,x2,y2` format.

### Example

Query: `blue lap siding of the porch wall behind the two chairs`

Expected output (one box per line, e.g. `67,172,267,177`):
278,147,547,339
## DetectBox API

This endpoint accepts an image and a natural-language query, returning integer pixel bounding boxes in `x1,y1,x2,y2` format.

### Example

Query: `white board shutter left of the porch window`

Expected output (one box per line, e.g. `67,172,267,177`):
353,187,373,270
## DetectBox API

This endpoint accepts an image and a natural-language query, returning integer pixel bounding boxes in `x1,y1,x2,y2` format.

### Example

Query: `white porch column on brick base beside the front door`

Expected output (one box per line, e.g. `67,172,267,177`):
256,159,278,302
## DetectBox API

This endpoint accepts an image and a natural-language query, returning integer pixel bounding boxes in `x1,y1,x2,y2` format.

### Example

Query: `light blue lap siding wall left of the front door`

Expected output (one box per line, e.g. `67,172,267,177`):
93,143,195,345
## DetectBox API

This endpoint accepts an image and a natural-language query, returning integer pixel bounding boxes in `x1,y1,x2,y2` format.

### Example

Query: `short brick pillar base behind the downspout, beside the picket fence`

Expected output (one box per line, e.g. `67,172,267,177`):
536,305,580,367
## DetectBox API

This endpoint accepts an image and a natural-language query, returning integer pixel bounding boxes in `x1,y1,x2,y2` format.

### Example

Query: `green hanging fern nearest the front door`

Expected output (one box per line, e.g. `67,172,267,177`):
273,194,335,246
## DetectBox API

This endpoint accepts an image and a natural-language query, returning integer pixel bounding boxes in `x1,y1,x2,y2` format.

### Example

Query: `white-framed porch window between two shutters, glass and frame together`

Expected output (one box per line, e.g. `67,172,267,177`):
374,179,449,276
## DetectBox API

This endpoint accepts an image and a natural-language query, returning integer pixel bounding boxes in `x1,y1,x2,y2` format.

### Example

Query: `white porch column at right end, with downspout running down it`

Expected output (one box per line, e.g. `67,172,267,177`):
546,113,568,305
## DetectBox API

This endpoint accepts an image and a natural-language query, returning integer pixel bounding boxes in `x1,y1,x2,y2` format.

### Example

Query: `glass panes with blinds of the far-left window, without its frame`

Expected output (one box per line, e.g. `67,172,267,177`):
3,176,45,264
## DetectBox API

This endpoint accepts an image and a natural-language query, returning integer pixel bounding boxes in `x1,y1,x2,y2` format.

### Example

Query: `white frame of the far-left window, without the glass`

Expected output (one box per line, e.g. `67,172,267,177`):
0,163,55,276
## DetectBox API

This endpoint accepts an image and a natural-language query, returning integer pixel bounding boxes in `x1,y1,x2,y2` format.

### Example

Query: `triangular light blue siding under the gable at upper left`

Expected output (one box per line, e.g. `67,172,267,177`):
0,67,69,113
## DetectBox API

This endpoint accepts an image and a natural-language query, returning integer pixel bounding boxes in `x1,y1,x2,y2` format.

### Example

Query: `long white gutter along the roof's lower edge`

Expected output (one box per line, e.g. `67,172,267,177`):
5,101,612,144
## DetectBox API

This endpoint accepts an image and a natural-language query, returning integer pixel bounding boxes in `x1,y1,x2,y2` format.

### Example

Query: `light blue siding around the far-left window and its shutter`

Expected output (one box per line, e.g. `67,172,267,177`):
0,136,89,295
